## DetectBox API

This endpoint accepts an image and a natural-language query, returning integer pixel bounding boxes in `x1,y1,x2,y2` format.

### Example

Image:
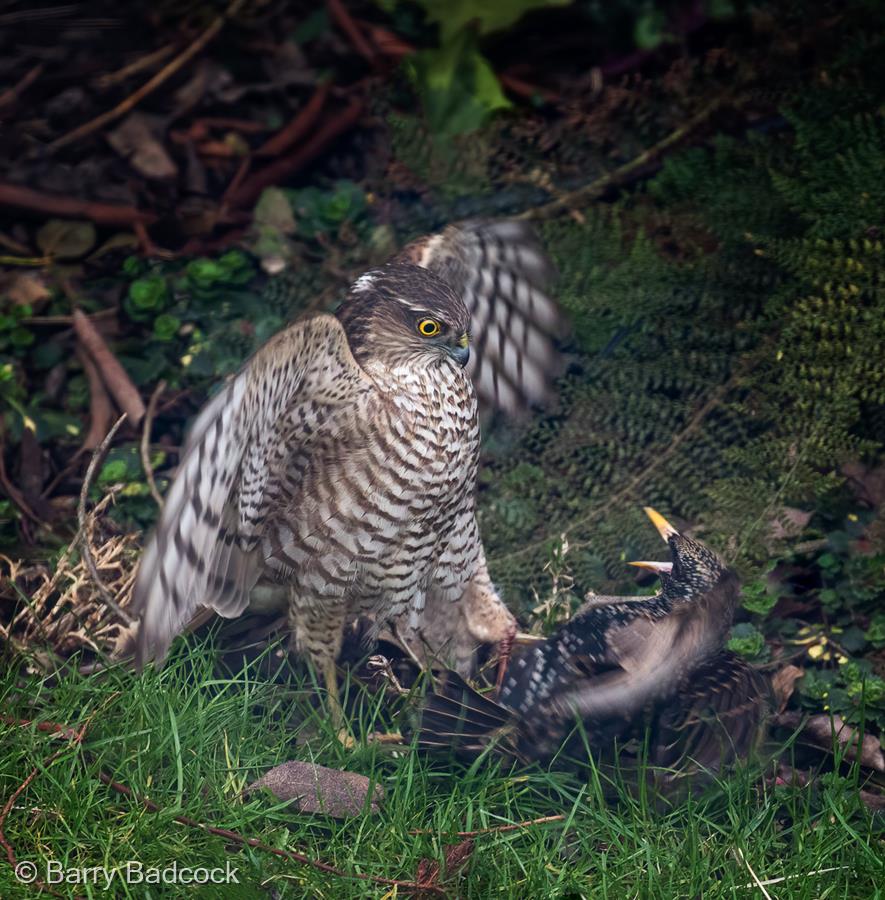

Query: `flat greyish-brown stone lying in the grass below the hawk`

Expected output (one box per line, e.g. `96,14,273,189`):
243,760,384,819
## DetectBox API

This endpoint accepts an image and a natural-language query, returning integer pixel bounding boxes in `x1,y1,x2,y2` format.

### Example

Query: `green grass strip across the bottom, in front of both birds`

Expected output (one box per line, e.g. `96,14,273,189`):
0,641,885,900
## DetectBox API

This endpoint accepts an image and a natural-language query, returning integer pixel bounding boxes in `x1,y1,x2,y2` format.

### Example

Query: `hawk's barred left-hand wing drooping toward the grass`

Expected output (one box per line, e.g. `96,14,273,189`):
133,315,371,666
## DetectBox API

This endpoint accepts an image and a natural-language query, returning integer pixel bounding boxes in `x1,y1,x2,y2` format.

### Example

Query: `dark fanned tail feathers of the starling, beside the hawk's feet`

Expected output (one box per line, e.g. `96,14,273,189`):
418,670,513,754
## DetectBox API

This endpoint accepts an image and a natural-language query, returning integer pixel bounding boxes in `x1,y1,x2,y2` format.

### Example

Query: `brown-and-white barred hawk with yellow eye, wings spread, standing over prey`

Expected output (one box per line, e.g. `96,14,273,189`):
135,222,559,724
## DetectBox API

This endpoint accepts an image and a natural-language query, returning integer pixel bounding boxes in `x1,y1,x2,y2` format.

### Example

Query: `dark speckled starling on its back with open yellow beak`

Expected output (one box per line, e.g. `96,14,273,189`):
419,510,767,777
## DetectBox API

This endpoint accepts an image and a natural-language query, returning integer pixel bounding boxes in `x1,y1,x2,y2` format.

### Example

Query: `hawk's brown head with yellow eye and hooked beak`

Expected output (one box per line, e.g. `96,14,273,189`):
337,263,470,366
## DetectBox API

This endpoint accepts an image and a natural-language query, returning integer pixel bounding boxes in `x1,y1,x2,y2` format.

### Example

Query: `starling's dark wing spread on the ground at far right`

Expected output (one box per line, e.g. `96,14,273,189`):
652,650,770,774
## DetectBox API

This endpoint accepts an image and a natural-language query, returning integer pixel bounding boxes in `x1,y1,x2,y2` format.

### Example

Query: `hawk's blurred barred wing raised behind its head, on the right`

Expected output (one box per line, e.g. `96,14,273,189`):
399,220,565,412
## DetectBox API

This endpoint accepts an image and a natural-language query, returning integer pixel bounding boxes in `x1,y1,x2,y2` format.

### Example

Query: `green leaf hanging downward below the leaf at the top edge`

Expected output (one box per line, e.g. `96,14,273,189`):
411,28,511,136
